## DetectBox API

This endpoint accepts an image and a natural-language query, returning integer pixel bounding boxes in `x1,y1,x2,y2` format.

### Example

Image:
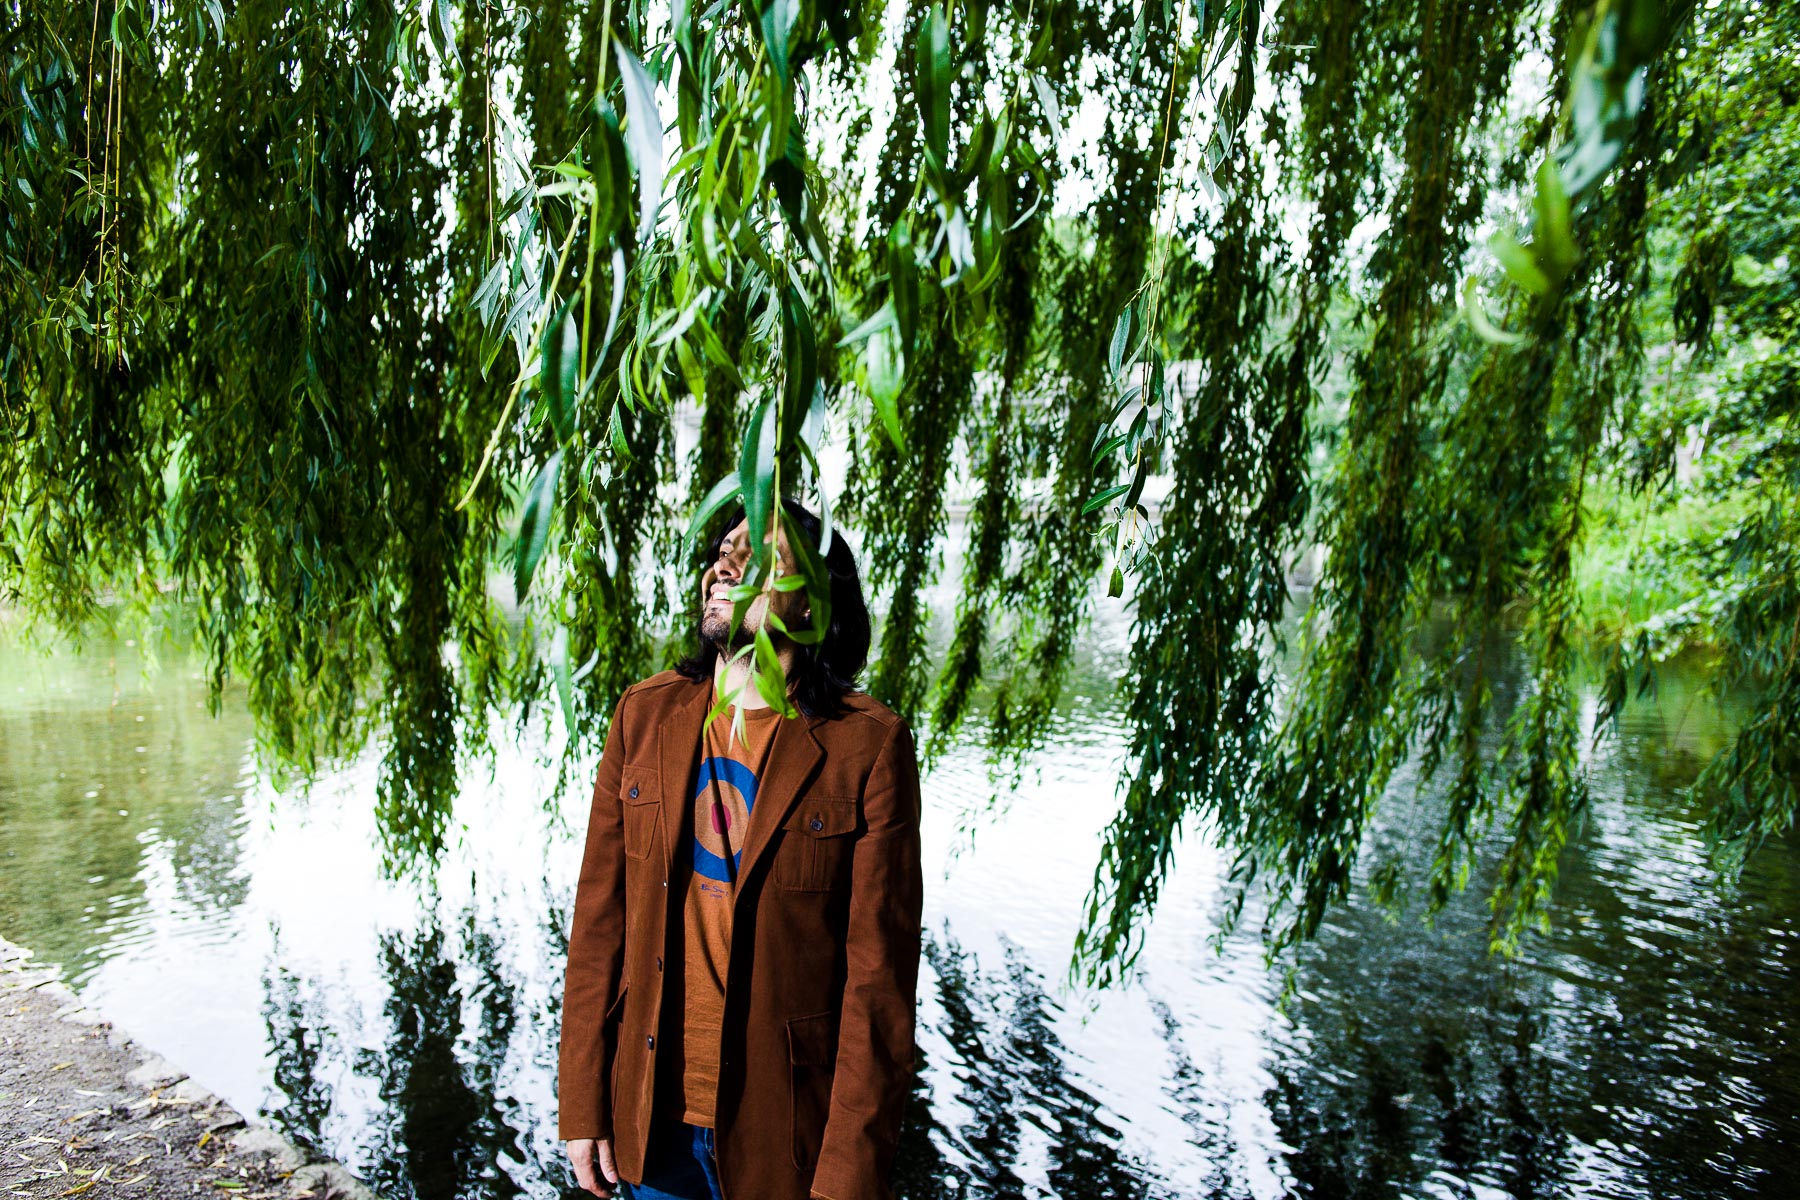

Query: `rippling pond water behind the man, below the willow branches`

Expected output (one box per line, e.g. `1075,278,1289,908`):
0,619,1800,1200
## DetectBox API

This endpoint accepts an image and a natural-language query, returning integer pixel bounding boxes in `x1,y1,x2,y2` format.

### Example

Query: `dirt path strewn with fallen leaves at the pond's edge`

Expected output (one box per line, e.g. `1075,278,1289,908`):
0,939,374,1200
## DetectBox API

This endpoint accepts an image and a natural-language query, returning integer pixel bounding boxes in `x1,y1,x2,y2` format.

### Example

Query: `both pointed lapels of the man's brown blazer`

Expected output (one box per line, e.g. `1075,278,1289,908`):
657,680,824,880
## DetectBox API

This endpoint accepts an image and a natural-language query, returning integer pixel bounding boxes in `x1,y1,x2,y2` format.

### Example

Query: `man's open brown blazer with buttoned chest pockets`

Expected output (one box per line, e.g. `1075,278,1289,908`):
558,671,923,1200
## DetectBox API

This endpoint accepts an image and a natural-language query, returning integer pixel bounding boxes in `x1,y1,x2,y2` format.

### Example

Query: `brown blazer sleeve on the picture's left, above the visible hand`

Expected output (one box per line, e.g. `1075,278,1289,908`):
556,691,630,1141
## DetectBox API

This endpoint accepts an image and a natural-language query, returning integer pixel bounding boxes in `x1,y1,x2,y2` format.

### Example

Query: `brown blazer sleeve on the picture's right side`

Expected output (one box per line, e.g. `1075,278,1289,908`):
812,720,923,1200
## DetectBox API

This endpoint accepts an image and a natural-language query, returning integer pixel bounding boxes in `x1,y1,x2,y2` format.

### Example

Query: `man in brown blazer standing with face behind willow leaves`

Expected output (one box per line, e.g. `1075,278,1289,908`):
558,500,922,1200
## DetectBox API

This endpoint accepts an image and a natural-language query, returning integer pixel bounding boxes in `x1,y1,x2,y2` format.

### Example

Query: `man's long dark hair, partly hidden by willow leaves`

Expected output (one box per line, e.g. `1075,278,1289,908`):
675,497,869,716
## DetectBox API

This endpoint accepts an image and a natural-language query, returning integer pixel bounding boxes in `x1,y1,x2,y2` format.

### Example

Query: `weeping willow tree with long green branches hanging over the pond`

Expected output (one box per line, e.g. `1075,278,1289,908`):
0,0,1800,981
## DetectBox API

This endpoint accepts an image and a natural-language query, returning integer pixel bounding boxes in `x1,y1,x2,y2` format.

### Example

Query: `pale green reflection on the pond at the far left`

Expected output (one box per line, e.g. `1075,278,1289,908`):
0,644,250,972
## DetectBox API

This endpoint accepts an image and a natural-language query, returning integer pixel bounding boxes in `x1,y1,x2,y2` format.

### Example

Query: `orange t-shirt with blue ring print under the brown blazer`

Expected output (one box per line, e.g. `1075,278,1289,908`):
657,694,781,1126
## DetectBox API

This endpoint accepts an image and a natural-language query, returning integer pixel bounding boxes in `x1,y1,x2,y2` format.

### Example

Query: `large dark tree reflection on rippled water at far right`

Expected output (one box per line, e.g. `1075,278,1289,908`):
1269,694,1800,1200
